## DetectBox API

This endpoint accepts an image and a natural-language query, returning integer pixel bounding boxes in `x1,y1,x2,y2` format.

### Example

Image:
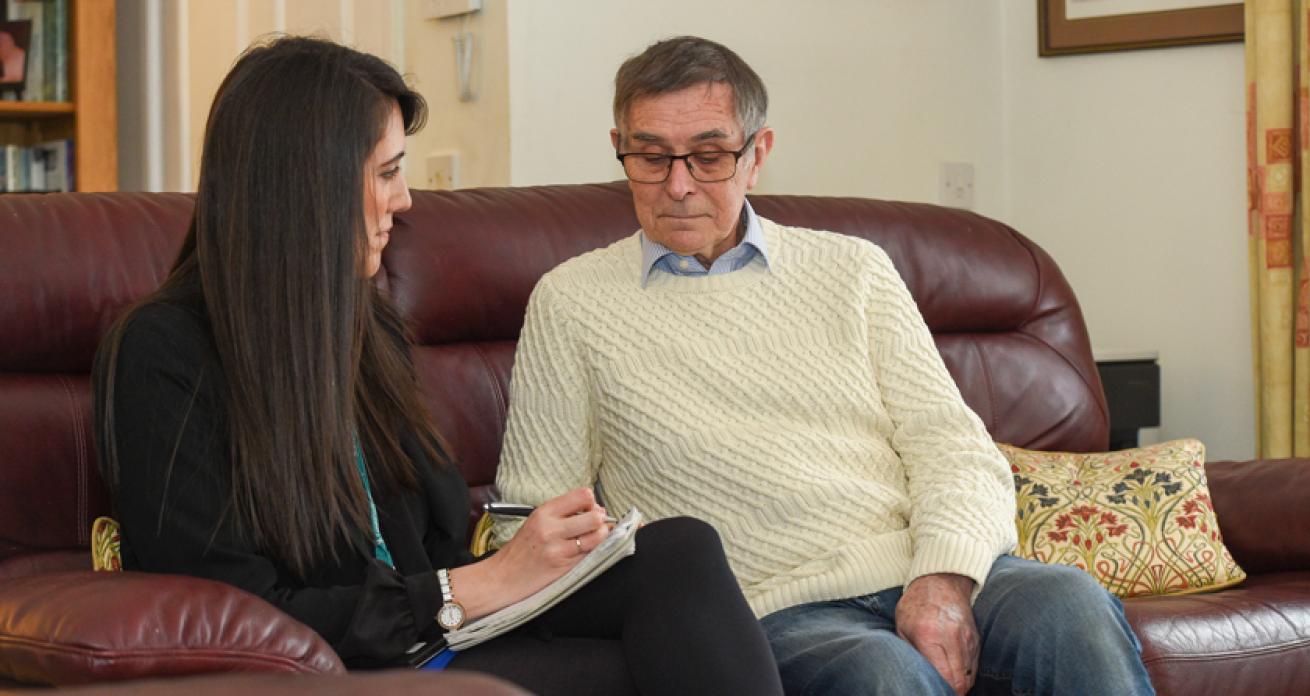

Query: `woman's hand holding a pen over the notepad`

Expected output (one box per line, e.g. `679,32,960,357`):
451,488,609,619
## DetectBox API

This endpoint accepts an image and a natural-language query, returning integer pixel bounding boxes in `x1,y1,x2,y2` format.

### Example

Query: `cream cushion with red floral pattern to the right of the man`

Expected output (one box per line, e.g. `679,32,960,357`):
1000,439,1246,598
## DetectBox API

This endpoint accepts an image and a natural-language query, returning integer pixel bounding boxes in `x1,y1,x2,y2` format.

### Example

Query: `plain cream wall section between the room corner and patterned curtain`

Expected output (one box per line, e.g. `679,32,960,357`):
1001,1,1255,460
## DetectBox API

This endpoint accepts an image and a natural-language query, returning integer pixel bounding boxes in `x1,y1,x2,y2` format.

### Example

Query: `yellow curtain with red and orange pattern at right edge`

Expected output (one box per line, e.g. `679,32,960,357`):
1246,0,1310,457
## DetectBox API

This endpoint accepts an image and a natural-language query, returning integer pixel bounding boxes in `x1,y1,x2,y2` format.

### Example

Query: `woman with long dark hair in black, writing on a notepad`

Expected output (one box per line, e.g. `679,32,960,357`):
96,38,781,693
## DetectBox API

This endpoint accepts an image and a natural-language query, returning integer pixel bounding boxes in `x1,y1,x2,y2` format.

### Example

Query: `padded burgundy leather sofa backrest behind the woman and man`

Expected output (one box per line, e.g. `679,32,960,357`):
0,184,1108,577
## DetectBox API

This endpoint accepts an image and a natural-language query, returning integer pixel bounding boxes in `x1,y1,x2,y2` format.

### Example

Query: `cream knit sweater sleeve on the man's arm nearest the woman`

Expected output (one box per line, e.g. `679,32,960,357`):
494,274,600,545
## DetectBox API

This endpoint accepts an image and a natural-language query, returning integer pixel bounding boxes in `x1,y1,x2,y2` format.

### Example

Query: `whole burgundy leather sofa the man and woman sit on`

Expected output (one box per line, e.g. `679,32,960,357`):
0,184,1310,696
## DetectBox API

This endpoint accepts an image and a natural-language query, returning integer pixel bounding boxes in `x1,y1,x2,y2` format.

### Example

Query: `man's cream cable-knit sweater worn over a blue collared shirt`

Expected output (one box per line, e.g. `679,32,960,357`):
496,219,1015,616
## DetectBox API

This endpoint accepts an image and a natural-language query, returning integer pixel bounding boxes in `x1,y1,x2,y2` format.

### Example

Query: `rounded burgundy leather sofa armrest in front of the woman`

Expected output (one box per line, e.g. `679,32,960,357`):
0,571,345,686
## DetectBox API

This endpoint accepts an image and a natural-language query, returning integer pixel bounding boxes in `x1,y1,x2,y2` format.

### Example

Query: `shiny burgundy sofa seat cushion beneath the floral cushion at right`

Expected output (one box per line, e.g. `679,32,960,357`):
1124,571,1310,696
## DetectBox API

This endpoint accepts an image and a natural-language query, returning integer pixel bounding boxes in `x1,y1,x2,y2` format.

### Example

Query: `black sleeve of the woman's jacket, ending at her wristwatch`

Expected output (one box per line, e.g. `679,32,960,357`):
97,305,439,663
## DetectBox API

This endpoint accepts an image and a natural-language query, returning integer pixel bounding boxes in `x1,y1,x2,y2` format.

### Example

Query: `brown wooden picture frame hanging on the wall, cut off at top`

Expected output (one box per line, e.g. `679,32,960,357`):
1038,0,1245,56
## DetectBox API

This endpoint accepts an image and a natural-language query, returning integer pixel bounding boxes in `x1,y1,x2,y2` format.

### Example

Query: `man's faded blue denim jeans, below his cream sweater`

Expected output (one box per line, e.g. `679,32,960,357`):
761,556,1155,696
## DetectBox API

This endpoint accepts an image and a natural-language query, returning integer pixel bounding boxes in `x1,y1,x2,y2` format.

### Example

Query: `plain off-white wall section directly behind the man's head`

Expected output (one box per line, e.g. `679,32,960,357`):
508,0,1005,215
